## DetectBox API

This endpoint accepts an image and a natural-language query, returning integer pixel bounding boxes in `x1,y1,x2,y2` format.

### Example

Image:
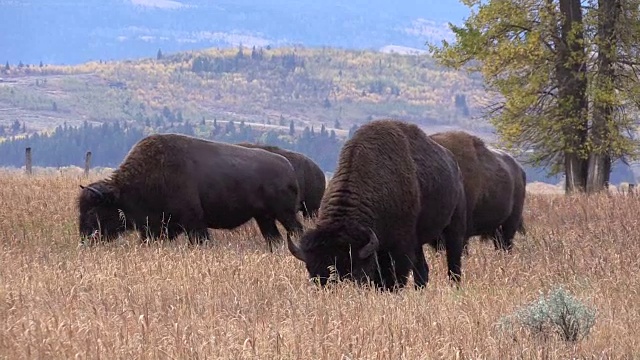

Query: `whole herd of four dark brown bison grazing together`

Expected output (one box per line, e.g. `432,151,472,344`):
77,119,526,290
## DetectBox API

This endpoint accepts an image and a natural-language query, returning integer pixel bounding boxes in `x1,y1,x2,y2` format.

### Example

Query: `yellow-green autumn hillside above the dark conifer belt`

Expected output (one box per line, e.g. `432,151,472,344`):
0,47,491,136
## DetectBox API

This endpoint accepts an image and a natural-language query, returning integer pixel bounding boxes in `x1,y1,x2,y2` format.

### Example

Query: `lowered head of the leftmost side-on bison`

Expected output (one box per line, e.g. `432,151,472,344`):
78,181,125,240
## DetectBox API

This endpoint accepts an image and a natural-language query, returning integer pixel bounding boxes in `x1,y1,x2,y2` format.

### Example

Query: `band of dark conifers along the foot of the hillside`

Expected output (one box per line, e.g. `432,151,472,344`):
0,121,635,184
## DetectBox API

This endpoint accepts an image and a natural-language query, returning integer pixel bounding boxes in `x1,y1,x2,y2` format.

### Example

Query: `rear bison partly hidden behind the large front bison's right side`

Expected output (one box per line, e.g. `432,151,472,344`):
430,131,527,250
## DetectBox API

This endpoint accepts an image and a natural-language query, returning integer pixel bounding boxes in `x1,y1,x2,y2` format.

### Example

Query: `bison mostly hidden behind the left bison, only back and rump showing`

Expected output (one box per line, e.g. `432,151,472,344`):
237,143,327,218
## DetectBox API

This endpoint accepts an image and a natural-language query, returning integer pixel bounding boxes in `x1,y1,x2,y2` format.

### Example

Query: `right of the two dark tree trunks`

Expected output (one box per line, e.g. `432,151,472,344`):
587,0,620,193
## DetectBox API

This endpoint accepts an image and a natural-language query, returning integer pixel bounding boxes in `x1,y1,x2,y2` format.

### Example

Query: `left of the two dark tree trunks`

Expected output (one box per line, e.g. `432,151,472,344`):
555,0,588,193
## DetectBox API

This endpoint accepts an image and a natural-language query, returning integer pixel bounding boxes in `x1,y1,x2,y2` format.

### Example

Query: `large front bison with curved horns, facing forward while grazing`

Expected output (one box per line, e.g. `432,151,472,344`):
287,119,466,289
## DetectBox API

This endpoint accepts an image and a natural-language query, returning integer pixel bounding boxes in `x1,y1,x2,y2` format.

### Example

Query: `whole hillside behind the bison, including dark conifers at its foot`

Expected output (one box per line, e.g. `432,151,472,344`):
0,47,490,176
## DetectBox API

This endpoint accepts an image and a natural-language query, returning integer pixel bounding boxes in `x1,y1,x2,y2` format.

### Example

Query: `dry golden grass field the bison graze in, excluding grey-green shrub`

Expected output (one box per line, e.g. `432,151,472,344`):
0,174,640,359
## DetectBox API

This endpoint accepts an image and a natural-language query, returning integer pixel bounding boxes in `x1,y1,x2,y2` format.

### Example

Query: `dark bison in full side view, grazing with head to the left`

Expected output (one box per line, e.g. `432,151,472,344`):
77,134,302,250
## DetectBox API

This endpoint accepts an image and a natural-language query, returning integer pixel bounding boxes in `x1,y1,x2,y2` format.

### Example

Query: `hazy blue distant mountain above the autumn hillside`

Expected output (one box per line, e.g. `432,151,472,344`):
0,0,468,64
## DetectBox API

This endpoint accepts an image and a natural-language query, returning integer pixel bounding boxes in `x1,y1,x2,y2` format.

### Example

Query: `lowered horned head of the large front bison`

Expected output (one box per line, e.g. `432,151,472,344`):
287,226,379,286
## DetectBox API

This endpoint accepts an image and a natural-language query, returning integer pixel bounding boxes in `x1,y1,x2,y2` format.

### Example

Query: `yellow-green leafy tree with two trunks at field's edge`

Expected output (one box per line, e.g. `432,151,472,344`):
429,0,640,192
